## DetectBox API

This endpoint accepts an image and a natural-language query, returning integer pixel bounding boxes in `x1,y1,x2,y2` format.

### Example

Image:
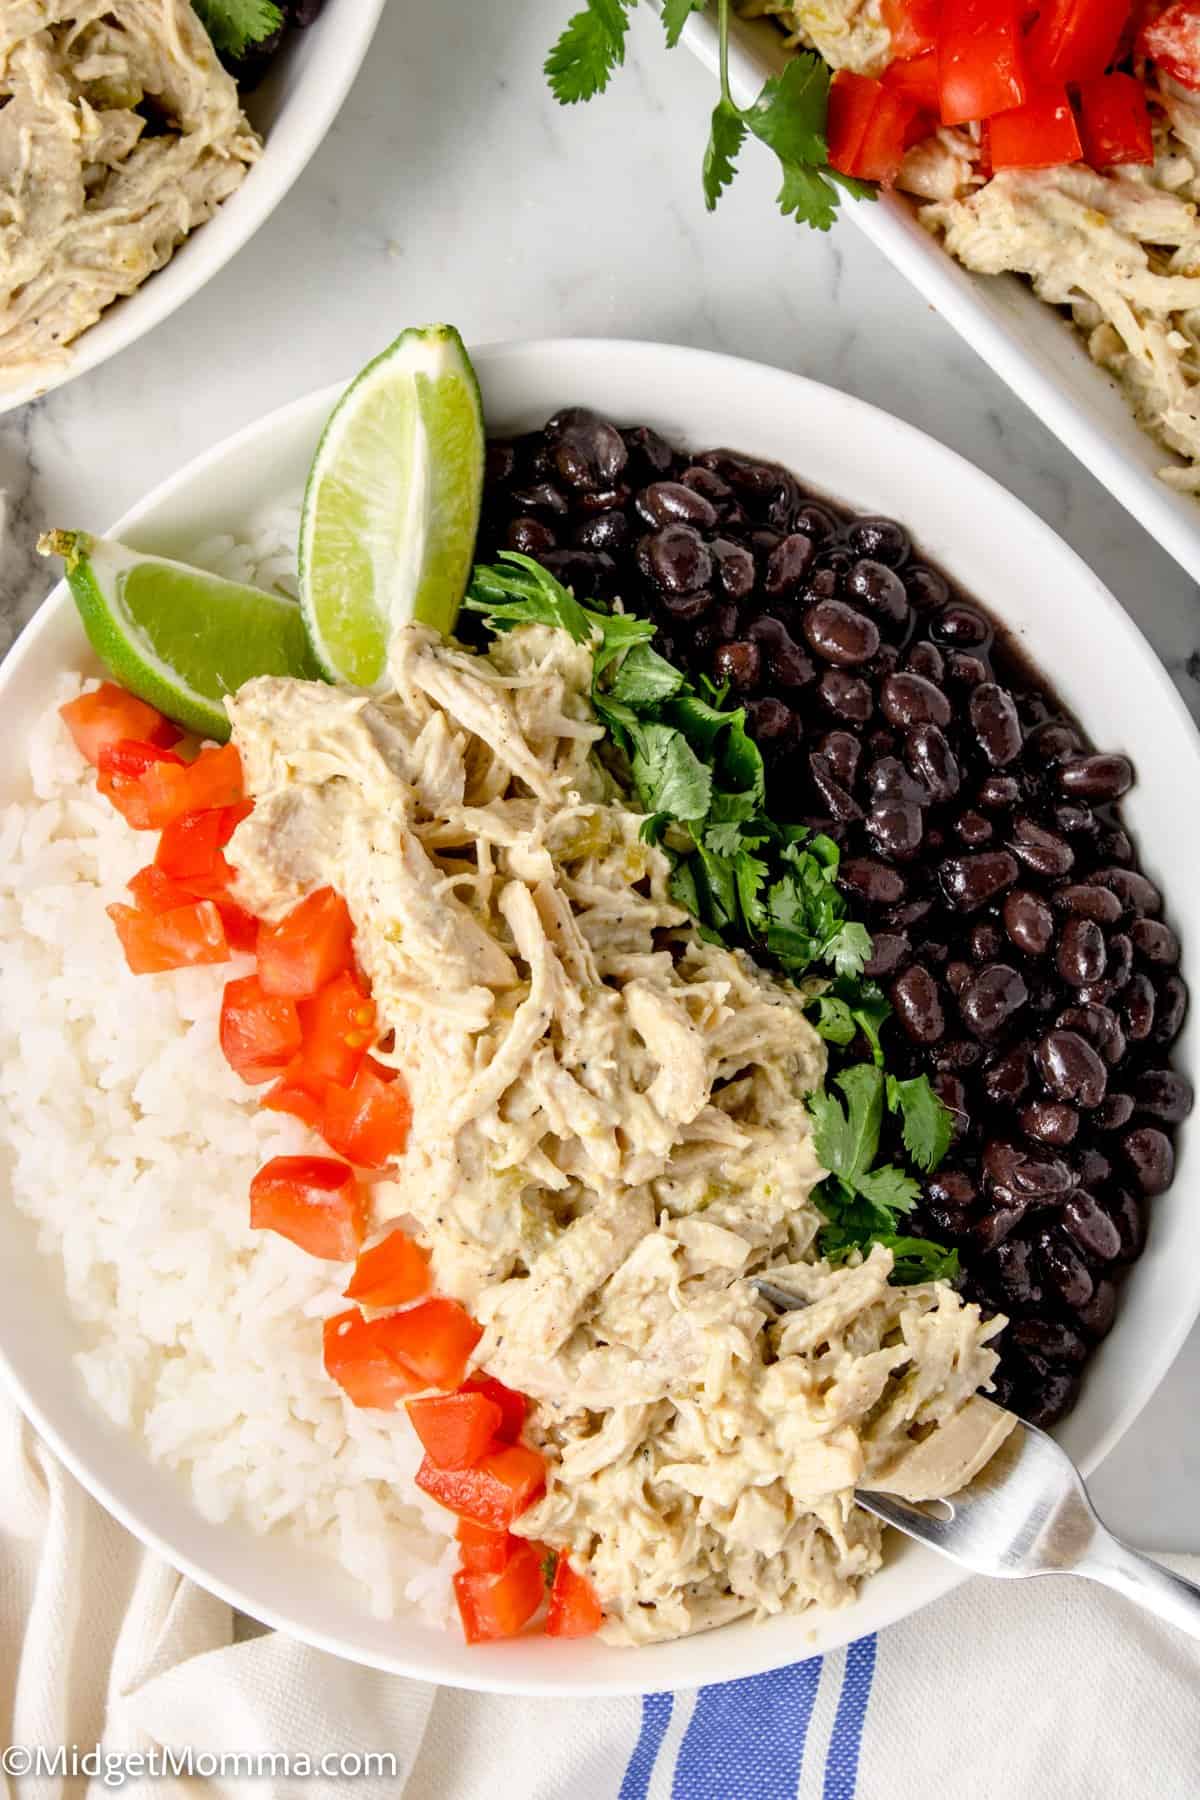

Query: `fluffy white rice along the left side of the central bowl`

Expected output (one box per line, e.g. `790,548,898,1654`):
0,513,455,1620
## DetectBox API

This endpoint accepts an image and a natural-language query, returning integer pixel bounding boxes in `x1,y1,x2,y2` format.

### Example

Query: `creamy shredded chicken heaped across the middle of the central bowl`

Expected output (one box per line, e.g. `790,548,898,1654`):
228,626,1011,1643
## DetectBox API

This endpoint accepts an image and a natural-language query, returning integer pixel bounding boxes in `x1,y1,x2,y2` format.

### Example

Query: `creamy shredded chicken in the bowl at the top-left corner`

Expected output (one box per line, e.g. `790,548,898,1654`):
0,0,259,380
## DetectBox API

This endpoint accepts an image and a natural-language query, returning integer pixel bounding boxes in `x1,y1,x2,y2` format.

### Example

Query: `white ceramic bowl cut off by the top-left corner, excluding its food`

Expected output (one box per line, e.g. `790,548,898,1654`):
0,0,385,414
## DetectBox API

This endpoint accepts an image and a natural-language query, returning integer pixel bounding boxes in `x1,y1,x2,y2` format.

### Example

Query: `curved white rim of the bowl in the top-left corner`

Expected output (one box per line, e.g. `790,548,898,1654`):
0,0,387,416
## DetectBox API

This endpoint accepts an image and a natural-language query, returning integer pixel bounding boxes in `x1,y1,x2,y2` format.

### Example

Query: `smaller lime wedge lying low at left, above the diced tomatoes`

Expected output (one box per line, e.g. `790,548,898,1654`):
38,531,320,743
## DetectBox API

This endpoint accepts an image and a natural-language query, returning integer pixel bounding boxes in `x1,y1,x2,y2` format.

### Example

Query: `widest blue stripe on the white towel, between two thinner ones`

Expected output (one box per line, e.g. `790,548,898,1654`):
671,1656,820,1800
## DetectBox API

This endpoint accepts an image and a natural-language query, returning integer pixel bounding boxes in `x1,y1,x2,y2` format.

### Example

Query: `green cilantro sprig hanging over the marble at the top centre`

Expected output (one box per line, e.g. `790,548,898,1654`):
545,0,874,230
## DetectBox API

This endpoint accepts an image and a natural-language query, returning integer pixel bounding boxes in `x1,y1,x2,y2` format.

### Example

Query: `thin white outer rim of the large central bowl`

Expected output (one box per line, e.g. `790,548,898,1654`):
0,338,1200,1699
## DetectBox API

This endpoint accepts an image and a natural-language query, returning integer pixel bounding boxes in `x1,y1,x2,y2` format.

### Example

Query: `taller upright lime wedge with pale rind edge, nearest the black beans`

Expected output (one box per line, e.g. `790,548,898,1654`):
300,326,484,691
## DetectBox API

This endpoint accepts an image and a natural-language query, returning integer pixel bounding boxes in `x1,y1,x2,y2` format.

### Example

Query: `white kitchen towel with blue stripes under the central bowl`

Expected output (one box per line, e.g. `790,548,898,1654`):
0,1395,1200,1800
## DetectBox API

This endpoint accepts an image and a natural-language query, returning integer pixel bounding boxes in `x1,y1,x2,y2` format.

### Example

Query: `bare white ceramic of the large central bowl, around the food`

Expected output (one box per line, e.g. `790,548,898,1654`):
0,340,1200,1696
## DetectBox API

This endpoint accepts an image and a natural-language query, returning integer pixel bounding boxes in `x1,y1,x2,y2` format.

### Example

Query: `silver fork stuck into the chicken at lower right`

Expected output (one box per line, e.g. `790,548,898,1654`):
855,1420,1200,1638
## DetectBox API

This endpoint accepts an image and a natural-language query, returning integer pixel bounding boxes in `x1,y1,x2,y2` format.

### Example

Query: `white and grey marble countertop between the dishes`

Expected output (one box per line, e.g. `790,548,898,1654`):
0,0,1200,1550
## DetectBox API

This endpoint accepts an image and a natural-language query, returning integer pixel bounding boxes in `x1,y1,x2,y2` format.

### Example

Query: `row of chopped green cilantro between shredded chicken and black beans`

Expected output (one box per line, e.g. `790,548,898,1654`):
466,551,957,1282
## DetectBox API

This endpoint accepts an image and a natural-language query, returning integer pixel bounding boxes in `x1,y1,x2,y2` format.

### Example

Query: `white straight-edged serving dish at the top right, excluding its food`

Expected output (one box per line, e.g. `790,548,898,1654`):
685,14,1200,581
